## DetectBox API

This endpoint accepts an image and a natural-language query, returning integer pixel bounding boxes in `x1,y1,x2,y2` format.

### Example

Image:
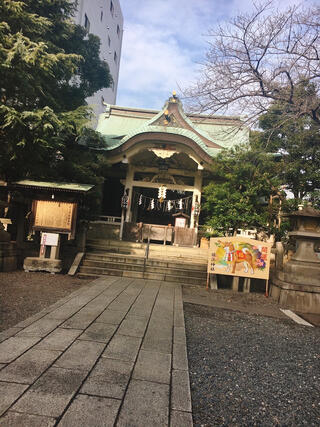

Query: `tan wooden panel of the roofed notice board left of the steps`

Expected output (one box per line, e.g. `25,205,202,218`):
34,200,76,231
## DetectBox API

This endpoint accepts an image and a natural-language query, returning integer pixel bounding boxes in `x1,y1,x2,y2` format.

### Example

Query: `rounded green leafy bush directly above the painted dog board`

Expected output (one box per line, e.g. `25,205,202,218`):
204,146,279,234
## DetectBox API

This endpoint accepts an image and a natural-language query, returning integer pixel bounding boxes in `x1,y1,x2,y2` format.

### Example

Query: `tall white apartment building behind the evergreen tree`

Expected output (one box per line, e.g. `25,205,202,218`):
74,0,123,118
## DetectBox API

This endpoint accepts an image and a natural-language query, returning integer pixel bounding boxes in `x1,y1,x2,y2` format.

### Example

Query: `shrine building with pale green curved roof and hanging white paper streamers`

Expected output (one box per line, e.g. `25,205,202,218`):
97,93,249,245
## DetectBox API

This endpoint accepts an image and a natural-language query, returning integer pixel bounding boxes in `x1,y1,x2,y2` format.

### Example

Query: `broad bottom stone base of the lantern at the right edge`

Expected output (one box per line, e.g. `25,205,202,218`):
270,278,320,314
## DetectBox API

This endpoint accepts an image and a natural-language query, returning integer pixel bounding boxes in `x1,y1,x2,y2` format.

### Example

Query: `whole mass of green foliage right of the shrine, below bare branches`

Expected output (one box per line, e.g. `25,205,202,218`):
204,95,320,239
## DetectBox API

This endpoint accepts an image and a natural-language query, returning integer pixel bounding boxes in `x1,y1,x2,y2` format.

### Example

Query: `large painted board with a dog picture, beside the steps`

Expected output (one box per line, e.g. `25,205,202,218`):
208,236,272,280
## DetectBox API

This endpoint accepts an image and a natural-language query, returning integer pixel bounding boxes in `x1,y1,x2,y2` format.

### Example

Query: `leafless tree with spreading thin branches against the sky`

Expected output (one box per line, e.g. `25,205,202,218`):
185,0,320,123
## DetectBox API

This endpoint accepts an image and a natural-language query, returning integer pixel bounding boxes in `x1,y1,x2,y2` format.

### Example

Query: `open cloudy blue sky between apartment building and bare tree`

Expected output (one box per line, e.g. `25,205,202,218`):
117,0,312,109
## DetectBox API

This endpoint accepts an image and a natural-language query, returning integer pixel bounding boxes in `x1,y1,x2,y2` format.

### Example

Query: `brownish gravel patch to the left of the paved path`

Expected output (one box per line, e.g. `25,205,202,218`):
0,271,89,331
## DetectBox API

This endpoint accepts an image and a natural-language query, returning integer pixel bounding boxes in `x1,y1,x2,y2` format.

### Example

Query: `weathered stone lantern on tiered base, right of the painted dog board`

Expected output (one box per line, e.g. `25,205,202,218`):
271,205,320,313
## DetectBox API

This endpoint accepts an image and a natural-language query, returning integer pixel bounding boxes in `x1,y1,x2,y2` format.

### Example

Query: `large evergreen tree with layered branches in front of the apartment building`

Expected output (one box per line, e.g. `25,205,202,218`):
0,0,111,182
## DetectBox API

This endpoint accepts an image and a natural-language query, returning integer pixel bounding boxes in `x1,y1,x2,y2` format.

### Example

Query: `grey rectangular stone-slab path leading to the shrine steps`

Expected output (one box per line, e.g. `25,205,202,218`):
0,277,192,427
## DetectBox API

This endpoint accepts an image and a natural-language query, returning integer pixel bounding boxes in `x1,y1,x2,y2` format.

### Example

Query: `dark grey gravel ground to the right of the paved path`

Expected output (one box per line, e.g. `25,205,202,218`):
184,303,320,426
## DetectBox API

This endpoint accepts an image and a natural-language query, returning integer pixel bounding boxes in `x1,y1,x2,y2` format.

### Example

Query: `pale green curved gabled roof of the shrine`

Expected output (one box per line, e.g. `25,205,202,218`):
97,95,248,158
